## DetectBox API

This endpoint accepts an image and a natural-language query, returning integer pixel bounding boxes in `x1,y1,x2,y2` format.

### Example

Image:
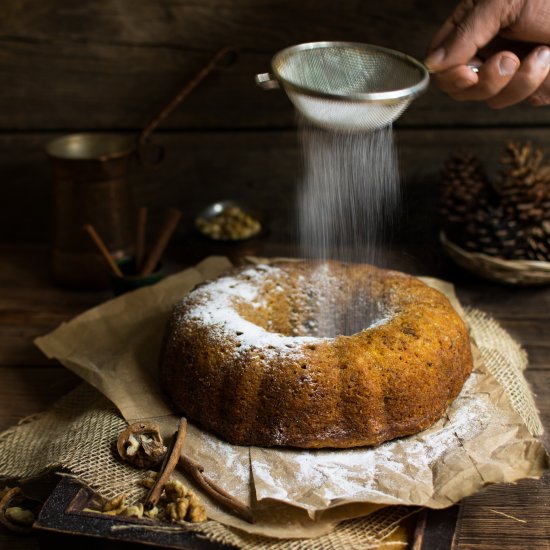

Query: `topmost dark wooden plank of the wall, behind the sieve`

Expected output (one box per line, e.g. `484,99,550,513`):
0,0,550,130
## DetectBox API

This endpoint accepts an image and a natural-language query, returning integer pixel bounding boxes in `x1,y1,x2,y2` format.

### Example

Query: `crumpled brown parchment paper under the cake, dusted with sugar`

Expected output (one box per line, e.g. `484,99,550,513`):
35,257,548,538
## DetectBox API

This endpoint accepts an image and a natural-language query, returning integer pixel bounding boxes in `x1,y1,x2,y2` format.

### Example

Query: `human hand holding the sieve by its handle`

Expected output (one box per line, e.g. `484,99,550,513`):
425,0,550,109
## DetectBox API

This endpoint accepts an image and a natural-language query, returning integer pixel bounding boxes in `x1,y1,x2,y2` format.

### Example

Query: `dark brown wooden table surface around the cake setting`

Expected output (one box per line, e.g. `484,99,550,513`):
0,241,550,550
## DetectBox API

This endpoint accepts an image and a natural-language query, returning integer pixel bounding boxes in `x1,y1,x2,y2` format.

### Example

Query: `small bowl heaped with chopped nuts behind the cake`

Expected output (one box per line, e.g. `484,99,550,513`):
195,200,265,242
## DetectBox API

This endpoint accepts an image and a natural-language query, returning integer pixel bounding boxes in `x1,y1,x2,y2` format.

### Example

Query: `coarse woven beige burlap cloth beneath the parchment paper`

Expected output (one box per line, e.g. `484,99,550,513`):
0,258,547,550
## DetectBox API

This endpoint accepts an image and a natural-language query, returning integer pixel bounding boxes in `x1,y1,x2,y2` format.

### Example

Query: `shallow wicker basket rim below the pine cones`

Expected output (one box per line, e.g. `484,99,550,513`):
439,232,550,286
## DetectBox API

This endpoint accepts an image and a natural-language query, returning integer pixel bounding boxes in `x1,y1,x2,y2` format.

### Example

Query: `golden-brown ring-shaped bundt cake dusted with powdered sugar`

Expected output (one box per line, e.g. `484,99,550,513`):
159,260,472,448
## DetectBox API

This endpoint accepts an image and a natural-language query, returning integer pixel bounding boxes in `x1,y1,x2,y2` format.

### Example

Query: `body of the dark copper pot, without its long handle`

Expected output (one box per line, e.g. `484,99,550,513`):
46,133,139,290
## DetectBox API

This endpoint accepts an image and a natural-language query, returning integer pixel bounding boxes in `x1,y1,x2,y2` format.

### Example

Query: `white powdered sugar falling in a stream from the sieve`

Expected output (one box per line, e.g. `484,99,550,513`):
298,120,400,336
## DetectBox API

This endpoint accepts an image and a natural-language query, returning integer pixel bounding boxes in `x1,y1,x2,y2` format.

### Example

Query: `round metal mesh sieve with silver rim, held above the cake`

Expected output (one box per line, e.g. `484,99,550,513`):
255,42,430,131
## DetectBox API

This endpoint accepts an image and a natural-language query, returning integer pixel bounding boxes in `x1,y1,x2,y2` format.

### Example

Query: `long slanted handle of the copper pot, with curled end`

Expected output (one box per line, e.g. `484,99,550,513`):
138,47,236,167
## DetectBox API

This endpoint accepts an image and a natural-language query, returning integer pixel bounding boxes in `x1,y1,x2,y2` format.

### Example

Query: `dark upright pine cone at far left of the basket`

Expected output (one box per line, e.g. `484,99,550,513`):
438,153,490,233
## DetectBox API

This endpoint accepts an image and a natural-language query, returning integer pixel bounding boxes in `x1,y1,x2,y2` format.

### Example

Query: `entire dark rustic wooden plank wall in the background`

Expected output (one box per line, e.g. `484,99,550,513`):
0,0,550,246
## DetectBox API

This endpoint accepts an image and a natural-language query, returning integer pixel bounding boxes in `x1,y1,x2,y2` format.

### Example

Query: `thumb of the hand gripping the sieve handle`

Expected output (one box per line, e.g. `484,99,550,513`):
424,0,504,72
